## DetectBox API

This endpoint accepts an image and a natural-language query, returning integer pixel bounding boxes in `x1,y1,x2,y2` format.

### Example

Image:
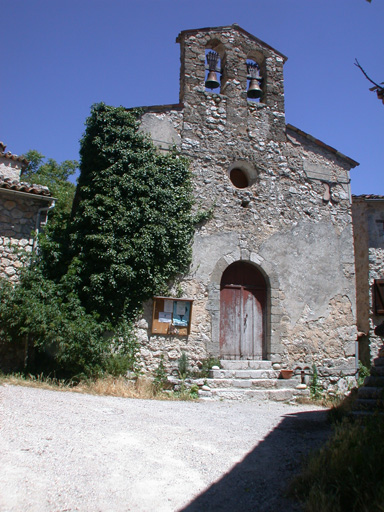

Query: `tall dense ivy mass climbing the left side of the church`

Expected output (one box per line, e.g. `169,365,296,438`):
68,104,194,323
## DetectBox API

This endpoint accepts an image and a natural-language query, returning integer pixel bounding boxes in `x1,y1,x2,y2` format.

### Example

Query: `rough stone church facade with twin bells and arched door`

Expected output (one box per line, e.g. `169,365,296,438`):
134,25,358,389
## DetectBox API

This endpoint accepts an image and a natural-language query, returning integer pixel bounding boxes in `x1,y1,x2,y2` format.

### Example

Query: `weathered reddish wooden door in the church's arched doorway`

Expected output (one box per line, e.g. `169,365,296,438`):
220,261,267,359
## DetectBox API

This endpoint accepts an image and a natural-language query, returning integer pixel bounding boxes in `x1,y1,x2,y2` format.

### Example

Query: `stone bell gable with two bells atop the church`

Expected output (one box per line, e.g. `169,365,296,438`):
176,24,287,141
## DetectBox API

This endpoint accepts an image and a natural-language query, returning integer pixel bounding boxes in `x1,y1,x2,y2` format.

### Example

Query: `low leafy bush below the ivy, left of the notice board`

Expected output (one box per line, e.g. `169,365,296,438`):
0,265,135,377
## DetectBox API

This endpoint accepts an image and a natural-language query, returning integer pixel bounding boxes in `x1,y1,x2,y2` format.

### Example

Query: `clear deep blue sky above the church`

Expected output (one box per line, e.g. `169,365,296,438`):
0,0,384,195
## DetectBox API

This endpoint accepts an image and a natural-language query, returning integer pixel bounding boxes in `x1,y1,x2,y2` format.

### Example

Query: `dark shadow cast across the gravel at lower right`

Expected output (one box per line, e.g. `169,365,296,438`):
179,410,330,512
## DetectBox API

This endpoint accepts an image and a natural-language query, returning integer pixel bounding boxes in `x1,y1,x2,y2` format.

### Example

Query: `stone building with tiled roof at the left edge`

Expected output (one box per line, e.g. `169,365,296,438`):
0,142,53,281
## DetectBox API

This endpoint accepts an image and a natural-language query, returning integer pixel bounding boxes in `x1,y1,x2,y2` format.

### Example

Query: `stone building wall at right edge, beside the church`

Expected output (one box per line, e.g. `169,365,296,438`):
352,196,384,364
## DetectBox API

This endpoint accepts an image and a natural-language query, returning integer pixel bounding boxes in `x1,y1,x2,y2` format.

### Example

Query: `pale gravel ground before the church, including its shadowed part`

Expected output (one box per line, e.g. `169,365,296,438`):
0,385,329,512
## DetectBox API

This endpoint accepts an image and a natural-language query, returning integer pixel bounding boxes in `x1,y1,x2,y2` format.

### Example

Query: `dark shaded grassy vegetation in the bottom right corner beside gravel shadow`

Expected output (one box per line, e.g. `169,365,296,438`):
291,416,384,512
